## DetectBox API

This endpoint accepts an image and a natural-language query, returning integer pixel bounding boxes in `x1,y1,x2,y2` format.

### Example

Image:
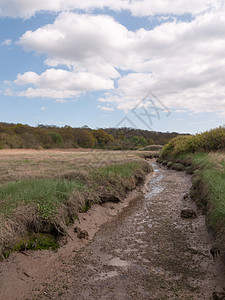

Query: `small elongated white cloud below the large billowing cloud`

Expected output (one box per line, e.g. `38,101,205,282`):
14,69,114,99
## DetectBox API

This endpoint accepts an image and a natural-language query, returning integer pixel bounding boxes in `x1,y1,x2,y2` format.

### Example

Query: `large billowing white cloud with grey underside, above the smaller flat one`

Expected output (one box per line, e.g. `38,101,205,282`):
19,13,126,78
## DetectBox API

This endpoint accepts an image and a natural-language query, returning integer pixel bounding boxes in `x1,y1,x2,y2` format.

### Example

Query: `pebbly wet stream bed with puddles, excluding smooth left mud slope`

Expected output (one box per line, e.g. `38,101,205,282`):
34,162,225,300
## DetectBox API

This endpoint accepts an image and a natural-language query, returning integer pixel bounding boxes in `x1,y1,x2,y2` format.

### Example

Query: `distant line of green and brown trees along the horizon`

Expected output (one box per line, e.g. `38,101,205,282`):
0,122,183,150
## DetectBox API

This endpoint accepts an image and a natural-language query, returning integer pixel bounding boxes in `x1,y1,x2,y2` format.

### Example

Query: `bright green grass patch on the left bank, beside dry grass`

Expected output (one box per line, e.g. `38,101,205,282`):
0,179,85,219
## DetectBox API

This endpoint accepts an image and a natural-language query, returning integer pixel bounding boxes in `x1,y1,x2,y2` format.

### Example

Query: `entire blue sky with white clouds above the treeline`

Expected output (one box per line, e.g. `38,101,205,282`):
0,0,225,133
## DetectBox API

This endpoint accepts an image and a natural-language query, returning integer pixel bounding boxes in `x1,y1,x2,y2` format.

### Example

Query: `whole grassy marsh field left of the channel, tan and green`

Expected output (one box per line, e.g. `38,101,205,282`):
0,150,151,254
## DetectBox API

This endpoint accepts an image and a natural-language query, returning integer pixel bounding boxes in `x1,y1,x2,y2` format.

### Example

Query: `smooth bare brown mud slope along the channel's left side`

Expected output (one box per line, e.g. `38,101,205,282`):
0,189,145,300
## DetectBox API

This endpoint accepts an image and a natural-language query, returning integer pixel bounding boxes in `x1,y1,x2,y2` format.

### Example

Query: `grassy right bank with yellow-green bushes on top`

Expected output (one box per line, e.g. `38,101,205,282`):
161,127,225,250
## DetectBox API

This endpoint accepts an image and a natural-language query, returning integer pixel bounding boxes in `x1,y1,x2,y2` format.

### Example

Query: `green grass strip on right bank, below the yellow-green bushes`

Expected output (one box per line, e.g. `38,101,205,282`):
173,153,225,241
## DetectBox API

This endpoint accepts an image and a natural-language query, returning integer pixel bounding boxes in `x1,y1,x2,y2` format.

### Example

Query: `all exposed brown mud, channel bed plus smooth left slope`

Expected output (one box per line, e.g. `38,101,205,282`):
0,163,225,300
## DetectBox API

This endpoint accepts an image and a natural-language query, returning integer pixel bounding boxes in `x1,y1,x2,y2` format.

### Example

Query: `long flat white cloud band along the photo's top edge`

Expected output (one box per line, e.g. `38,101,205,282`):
0,0,215,18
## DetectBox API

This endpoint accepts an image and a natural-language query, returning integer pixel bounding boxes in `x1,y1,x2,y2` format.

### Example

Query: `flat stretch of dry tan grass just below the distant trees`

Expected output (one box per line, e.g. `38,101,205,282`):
0,149,146,183
